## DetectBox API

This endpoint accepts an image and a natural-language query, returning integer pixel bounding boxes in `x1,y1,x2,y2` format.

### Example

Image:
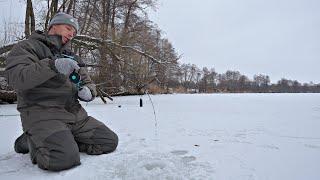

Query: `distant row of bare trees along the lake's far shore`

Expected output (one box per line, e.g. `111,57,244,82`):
164,64,320,93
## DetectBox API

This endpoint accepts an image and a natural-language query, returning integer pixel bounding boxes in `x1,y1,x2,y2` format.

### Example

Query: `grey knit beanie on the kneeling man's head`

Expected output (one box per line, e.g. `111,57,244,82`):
49,12,79,32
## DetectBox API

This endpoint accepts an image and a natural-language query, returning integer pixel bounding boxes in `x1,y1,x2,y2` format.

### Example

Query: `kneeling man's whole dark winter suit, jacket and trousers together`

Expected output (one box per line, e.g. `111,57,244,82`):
6,31,118,171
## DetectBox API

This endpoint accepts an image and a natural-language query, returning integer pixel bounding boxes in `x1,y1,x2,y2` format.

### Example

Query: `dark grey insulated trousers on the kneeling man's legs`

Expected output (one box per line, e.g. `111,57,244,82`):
21,107,118,171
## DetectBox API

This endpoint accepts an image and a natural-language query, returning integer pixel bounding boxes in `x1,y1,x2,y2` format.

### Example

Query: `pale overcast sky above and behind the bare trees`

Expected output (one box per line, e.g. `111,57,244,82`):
0,0,320,83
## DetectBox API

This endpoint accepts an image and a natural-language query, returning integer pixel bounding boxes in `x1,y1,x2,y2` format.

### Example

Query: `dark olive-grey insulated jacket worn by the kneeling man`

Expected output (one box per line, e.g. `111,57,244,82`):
6,31,97,110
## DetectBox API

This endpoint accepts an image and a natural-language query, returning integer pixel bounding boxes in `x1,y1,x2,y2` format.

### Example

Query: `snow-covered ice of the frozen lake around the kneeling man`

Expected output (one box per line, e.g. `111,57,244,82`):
0,94,320,180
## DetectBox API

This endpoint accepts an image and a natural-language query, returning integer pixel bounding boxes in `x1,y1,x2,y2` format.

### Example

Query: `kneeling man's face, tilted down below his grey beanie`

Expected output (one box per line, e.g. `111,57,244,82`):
48,24,76,44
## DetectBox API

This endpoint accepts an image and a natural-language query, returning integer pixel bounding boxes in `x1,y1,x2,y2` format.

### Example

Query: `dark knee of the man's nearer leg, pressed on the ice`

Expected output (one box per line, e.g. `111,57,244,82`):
29,131,80,171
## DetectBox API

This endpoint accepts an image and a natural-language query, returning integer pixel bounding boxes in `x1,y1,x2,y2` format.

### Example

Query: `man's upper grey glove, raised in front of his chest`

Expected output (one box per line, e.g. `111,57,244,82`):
54,58,80,76
